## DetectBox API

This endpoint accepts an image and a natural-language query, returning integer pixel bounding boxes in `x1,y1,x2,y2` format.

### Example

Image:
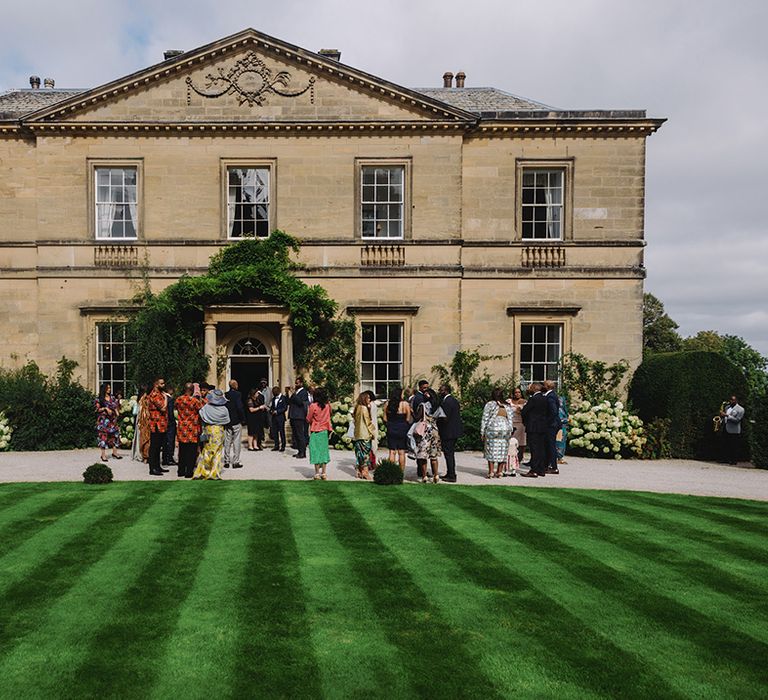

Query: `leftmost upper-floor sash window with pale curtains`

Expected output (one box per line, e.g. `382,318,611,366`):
94,165,139,239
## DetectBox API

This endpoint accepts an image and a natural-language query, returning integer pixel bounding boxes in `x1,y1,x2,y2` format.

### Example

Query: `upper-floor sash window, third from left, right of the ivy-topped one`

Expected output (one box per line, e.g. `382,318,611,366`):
360,163,406,239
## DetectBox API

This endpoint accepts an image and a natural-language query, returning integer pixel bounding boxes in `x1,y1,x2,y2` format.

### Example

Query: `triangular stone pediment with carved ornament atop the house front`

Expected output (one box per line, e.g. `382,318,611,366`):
25,29,474,125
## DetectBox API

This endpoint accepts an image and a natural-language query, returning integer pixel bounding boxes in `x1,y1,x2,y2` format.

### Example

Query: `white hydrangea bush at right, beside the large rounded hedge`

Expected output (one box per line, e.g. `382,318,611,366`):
568,401,647,459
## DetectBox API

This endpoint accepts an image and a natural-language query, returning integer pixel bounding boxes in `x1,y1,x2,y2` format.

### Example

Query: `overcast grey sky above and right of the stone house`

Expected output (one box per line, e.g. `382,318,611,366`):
0,0,768,354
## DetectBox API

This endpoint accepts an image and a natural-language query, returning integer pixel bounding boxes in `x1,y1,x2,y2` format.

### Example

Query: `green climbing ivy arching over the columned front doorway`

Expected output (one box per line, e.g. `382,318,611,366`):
128,231,355,396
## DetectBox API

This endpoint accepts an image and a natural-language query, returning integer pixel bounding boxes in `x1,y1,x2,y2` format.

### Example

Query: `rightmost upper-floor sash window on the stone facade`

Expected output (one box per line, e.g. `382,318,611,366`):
521,168,565,240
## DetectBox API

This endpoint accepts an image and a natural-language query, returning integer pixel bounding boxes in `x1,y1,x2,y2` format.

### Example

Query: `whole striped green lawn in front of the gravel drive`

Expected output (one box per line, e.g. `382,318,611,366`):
0,481,768,699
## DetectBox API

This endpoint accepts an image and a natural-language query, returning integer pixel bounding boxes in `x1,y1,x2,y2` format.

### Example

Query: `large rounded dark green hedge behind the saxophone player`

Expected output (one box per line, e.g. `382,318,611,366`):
629,351,749,460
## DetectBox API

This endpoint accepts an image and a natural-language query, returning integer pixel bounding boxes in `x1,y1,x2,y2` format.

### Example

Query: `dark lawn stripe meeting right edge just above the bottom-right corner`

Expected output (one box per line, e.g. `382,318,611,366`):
450,490,768,683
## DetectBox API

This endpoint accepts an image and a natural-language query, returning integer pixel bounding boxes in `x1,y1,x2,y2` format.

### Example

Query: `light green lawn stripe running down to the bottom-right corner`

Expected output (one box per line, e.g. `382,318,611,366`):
414,487,755,697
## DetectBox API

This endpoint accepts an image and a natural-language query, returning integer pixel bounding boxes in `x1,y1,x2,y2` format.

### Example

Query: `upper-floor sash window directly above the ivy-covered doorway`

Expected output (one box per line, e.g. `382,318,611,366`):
227,167,270,238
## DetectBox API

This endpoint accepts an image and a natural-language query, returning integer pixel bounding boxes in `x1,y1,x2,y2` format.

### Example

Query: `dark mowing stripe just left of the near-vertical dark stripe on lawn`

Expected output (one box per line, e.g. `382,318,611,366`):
71,483,223,697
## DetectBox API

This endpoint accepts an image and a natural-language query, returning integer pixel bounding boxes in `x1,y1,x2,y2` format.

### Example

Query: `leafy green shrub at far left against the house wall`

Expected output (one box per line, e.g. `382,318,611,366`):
0,357,96,451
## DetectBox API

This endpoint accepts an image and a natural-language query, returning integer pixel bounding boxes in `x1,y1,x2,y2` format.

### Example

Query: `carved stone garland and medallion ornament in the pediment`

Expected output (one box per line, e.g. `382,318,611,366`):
186,51,315,107
